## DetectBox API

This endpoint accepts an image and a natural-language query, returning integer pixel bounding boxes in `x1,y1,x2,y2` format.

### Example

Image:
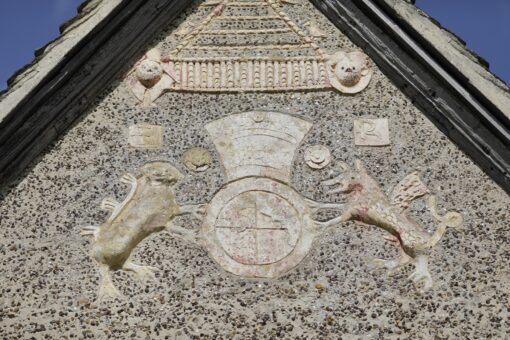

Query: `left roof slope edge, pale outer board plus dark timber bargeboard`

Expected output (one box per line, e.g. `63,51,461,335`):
0,0,193,191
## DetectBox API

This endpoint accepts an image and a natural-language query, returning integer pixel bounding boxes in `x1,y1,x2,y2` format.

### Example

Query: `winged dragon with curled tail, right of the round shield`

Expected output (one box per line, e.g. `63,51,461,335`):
324,160,463,290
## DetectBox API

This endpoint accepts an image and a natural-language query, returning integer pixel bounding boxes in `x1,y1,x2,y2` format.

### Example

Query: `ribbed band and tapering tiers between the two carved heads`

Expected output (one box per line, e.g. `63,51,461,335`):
164,0,330,92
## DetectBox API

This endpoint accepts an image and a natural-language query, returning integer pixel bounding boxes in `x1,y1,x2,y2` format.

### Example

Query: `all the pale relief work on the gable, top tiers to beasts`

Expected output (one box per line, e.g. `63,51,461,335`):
78,0,462,296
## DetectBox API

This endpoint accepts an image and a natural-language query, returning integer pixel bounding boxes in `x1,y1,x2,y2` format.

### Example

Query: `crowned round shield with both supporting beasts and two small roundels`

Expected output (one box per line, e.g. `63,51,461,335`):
82,111,462,297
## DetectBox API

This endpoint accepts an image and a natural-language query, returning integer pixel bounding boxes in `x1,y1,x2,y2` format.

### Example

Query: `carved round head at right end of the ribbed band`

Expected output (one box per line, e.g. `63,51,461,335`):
328,51,372,94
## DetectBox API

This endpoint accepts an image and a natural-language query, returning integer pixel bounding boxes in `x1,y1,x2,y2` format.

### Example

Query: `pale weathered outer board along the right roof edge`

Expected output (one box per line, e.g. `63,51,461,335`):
375,0,510,119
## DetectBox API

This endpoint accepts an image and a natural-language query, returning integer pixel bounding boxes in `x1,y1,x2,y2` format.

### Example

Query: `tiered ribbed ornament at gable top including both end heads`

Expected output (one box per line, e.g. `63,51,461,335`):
129,0,372,105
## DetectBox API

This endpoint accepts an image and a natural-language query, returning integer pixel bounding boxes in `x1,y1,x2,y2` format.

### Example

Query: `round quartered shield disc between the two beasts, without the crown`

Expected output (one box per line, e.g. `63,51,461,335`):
202,177,313,277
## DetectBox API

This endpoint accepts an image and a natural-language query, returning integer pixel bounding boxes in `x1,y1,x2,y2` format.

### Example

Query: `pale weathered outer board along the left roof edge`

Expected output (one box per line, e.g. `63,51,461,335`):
0,0,125,124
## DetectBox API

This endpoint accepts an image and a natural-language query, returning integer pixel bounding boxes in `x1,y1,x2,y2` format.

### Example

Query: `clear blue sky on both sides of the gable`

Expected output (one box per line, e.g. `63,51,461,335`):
0,0,510,89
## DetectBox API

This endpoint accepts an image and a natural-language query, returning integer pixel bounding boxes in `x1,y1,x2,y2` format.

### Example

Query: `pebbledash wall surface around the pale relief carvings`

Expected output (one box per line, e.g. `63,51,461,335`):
0,0,510,339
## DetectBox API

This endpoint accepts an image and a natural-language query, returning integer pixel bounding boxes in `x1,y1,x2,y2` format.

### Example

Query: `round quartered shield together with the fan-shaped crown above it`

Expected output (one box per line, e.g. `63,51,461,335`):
202,111,326,278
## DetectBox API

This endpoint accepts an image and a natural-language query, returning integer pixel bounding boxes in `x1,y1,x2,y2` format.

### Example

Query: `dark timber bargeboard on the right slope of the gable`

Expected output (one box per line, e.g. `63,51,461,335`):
310,0,510,193
